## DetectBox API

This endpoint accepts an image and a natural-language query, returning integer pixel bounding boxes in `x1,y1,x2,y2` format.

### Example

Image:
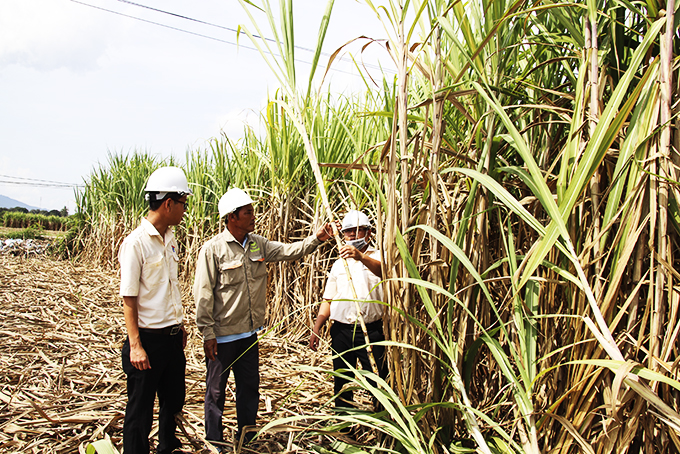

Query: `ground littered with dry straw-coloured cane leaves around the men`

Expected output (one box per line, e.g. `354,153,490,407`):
0,254,371,453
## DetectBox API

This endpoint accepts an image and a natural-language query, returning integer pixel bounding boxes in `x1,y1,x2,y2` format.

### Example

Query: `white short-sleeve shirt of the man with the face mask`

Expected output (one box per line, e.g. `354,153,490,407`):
323,247,384,324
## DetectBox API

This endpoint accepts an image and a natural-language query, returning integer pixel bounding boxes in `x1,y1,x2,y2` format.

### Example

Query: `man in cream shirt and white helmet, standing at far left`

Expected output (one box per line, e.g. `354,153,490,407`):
118,167,191,454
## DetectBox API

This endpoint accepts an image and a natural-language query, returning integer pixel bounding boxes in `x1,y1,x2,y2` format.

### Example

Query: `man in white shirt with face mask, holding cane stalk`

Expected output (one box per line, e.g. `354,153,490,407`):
309,210,387,408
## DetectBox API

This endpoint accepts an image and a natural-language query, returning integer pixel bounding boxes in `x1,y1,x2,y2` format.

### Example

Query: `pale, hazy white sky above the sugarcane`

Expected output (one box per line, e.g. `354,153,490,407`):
0,0,393,213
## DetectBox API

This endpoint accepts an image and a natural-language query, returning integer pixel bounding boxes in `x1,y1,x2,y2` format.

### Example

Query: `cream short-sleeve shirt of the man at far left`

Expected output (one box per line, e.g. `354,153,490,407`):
118,219,183,328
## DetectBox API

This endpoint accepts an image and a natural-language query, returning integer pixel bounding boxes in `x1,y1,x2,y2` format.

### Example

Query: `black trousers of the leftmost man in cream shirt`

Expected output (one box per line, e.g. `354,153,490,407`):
122,331,186,454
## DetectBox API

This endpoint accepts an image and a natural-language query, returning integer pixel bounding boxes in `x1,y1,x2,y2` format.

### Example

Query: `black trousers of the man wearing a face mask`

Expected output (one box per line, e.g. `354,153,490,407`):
330,320,387,408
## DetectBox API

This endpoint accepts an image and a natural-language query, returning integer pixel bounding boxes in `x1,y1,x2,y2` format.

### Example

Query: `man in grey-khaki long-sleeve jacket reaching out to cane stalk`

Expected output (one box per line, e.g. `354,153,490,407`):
194,188,332,447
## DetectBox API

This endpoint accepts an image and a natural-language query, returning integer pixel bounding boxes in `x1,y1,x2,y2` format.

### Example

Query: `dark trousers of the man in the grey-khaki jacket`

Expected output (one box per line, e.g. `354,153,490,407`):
204,334,260,442
